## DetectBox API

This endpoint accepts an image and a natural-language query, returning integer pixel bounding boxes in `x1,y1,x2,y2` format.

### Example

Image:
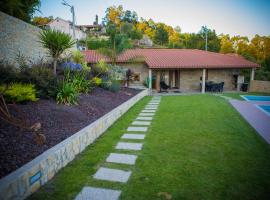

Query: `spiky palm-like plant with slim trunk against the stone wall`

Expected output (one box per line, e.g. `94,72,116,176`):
39,29,75,75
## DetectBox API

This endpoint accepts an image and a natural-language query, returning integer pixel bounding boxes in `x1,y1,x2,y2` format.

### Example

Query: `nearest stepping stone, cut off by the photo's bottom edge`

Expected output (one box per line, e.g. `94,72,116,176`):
75,186,121,200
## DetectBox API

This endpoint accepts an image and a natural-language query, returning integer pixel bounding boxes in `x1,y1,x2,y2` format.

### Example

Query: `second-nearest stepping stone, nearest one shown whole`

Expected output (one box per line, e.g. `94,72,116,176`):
94,167,131,183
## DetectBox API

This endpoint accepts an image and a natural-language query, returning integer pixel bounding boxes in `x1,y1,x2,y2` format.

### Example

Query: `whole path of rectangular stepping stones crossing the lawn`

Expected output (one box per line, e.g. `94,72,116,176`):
75,96,161,200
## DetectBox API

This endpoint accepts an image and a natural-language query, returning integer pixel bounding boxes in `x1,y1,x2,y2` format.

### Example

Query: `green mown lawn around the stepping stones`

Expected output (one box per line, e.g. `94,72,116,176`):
30,94,270,200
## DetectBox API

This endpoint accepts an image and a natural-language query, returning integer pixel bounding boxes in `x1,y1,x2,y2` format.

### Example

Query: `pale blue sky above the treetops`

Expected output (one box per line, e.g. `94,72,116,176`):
36,0,270,38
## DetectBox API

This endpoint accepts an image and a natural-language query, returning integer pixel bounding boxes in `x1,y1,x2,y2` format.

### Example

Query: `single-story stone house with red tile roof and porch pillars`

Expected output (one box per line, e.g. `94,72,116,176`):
83,49,260,92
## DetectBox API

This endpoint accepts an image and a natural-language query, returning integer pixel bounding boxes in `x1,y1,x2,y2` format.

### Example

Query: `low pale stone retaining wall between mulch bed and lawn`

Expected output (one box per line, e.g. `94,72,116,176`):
0,90,148,200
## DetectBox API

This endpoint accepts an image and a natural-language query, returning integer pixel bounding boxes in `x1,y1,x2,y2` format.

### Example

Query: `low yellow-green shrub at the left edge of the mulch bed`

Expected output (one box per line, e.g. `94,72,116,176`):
0,83,38,103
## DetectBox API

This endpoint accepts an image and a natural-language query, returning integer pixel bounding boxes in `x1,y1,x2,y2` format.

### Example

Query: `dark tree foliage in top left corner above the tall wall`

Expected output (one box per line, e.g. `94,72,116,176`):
0,0,40,22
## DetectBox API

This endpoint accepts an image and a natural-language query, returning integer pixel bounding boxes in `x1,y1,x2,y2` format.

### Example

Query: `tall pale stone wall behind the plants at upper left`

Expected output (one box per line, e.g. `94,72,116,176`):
0,12,48,65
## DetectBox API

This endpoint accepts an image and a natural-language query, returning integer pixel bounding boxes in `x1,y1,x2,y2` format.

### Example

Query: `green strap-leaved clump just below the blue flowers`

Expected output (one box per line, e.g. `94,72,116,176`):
56,81,78,105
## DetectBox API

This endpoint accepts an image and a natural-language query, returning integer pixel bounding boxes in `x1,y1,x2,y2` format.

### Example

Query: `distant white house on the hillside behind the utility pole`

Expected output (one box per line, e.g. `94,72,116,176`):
44,17,87,40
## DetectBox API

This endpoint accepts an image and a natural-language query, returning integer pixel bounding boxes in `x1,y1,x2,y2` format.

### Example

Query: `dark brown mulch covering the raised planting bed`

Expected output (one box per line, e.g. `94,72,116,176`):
0,88,139,178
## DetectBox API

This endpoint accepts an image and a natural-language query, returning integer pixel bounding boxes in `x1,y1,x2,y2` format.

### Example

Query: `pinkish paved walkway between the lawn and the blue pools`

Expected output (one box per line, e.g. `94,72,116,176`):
229,100,270,144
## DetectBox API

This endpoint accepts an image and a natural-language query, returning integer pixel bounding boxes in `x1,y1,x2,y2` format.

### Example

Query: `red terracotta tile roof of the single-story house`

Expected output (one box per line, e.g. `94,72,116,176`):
83,49,260,69
